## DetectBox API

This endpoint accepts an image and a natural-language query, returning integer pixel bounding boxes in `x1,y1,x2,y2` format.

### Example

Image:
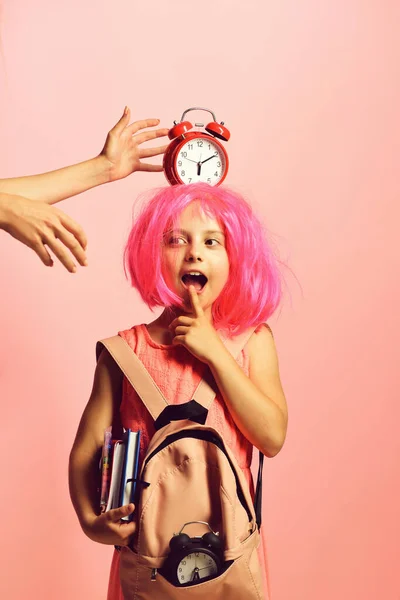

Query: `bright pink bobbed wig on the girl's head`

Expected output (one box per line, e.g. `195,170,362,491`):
125,183,282,335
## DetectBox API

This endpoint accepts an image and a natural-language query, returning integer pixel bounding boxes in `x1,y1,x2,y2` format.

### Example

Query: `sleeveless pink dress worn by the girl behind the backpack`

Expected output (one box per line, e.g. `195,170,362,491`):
107,325,271,600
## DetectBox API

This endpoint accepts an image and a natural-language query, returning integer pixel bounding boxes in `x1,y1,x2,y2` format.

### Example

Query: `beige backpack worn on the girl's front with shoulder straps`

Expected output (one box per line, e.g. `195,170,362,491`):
97,330,264,600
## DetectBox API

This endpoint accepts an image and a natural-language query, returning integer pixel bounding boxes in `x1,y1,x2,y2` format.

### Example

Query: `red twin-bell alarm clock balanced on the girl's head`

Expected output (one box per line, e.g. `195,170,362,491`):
163,108,231,185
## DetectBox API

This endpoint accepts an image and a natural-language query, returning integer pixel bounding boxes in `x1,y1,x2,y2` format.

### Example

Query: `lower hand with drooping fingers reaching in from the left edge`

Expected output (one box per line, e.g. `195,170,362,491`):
0,194,87,273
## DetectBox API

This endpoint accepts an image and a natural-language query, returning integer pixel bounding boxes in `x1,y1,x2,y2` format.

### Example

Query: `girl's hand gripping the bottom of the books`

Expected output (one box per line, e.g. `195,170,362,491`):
83,504,136,546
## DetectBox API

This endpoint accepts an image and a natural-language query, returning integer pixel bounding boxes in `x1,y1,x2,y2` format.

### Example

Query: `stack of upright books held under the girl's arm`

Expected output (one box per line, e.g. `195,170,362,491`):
100,427,140,521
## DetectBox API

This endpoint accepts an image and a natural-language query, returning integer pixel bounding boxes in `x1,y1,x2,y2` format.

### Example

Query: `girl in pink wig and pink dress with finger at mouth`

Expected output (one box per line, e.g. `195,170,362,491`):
70,183,287,600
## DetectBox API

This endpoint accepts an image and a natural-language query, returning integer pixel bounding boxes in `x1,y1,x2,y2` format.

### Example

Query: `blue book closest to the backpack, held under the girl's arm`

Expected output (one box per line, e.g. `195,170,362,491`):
119,429,140,521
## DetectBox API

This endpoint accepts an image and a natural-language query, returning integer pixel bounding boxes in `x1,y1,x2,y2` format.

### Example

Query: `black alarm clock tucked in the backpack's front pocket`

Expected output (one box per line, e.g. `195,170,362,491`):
160,521,223,586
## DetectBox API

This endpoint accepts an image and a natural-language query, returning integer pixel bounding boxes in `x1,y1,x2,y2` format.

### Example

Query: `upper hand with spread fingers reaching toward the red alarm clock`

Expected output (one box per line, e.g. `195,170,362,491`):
101,107,168,181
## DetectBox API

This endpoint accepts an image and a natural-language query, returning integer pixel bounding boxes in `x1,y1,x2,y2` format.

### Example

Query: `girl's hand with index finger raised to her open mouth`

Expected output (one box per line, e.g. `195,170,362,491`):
169,285,225,364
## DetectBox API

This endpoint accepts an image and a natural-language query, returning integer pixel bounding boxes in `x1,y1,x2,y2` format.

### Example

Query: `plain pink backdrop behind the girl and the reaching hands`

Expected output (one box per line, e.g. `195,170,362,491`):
0,0,400,600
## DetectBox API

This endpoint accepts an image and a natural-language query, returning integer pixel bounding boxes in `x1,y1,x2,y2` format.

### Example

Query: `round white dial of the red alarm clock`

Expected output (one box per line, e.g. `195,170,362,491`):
175,136,227,185
